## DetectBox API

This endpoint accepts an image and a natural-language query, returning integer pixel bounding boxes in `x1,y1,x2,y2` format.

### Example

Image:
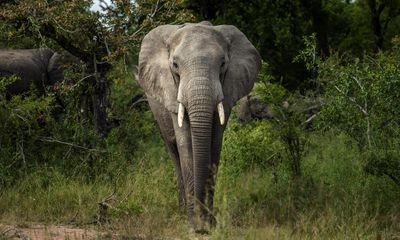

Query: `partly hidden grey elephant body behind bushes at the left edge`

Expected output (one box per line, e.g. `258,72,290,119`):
0,48,64,96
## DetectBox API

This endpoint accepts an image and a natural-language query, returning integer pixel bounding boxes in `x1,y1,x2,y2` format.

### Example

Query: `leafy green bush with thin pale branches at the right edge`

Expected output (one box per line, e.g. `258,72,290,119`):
310,35,400,185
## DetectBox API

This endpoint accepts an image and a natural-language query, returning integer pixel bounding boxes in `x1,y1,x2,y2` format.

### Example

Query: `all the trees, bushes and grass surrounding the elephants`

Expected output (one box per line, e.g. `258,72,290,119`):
0,0,400,239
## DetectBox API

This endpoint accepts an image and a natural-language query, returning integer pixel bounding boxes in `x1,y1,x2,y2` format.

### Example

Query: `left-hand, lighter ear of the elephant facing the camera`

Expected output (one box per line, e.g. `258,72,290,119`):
138,25,181,112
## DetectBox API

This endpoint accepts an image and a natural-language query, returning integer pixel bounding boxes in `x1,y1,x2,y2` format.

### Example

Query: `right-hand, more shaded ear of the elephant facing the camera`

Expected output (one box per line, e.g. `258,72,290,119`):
215,25,261,107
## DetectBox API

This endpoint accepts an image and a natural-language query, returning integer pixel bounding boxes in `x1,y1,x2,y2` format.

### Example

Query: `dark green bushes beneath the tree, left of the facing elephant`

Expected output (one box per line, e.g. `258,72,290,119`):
0,60,156,187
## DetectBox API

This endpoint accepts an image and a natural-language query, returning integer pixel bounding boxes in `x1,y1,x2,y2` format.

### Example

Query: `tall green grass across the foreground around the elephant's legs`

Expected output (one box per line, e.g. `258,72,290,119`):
0,126,400,239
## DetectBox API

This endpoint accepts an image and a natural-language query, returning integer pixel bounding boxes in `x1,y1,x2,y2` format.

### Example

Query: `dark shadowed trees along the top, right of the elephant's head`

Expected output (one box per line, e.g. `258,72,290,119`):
194,0,400,91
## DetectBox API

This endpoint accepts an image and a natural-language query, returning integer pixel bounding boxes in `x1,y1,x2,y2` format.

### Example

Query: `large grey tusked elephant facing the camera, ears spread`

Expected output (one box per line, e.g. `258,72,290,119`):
138,22,261,232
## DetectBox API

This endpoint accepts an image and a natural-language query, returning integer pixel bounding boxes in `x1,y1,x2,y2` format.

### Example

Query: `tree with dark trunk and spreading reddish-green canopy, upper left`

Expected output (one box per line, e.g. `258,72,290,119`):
0,0,191,137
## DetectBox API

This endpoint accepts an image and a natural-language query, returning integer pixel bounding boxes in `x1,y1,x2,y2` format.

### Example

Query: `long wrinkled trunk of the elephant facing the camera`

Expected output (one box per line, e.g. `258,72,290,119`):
187,77,216,218
